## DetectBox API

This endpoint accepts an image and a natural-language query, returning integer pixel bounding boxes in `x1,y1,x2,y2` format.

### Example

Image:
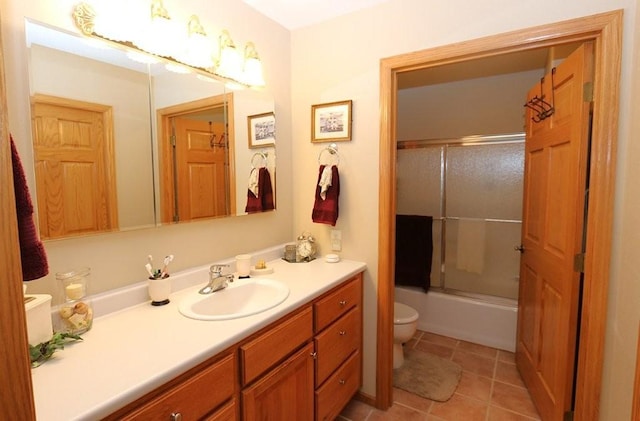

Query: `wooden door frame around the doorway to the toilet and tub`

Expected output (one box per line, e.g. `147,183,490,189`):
376,10,622,420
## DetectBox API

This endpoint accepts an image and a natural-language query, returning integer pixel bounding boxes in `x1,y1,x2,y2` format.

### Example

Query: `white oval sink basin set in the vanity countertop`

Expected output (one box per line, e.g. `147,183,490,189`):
178,278,289,320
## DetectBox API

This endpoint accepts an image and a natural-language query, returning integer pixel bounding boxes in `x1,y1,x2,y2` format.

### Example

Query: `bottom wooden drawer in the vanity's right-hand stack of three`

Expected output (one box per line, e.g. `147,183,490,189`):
315,351,362,421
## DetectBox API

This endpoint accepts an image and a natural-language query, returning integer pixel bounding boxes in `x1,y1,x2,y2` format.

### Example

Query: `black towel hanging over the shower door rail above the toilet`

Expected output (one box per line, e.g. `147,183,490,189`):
395,215,433,292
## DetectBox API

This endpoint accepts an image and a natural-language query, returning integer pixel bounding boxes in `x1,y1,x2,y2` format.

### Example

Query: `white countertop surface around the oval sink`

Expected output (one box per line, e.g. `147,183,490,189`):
32,251,366,421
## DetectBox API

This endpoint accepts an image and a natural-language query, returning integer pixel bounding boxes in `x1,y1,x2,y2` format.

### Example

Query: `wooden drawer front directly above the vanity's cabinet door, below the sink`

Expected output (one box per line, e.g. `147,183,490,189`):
240,306,313,386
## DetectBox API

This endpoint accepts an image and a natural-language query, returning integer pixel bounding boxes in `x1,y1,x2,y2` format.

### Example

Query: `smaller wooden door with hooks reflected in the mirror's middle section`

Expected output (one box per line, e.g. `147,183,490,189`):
174,117,229,221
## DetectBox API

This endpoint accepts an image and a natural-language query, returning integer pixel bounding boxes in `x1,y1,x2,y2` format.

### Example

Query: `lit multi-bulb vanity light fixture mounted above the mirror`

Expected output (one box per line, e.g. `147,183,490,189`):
73,0,265,87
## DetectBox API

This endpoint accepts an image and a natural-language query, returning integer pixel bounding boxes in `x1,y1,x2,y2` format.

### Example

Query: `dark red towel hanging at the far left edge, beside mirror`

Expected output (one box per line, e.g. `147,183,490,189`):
9,135,49,281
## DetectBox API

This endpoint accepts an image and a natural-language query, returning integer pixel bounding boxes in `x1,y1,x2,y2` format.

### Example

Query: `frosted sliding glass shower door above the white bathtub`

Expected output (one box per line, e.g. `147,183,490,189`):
397,135,524,299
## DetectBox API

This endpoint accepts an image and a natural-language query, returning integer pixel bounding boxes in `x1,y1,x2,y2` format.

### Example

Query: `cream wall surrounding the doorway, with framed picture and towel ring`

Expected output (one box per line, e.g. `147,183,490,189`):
291,0,640,414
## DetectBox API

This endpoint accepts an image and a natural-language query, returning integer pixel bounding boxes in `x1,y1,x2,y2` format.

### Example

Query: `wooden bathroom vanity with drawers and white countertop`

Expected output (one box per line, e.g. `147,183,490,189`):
33,254,365,420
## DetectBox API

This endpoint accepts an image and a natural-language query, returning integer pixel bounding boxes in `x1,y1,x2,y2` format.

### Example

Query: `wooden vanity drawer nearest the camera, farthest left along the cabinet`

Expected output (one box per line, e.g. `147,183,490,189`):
118,354,236,420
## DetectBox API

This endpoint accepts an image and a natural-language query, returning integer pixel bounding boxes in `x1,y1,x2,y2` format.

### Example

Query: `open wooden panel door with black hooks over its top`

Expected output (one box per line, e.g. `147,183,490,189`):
516,43,593,420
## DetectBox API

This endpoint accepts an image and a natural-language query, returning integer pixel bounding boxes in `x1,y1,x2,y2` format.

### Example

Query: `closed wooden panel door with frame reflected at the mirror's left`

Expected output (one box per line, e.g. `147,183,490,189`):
32,96,118,238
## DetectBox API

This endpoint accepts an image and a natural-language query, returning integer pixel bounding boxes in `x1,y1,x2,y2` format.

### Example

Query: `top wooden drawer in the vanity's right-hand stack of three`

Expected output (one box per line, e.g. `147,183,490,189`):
314,274,362,332
